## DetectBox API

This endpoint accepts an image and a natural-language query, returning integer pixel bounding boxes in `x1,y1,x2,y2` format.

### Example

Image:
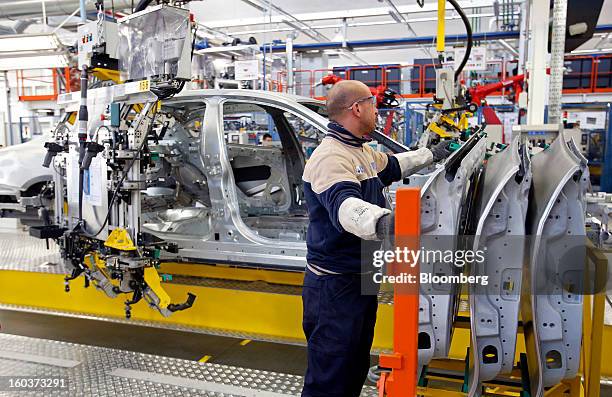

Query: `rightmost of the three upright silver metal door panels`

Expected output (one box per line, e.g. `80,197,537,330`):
521,132,586,396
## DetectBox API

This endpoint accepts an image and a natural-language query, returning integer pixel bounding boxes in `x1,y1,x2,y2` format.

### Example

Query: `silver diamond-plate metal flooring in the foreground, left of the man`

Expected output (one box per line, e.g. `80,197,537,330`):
0,334,376,397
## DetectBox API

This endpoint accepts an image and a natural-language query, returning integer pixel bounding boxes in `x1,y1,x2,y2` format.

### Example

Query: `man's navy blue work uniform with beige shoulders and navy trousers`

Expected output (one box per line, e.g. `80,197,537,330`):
302,123,402,397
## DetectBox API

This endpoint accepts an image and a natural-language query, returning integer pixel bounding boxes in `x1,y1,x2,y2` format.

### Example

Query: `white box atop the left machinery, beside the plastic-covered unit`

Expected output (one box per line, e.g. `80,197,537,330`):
77,21,119,70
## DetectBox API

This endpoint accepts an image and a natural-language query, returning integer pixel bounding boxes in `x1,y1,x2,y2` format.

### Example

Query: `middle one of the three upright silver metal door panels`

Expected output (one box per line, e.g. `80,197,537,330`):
469,136,531,396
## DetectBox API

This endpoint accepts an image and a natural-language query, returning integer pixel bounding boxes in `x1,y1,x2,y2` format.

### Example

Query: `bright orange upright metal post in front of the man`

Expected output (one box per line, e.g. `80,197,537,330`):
379,188,421,397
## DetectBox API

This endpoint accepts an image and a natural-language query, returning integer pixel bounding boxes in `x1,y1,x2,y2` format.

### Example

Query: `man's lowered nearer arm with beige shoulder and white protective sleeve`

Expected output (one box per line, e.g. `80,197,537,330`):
304,156,391,240
